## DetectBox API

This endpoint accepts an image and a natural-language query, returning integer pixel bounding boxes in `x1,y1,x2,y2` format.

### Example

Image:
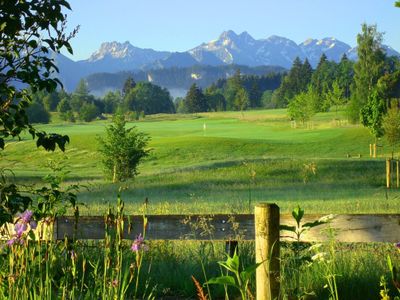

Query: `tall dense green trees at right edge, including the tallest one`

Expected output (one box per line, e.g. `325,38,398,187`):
271,24,400,138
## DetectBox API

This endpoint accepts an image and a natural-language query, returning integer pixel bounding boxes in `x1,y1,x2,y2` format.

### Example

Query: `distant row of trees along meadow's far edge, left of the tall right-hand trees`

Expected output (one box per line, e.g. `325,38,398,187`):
27,69,283,123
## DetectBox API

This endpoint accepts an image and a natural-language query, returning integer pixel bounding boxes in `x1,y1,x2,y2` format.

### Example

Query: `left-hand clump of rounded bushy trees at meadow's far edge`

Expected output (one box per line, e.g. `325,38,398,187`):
27,77,175,123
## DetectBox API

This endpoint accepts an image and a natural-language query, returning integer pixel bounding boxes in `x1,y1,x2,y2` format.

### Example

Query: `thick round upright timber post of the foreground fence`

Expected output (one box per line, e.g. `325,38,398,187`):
254,203,280,300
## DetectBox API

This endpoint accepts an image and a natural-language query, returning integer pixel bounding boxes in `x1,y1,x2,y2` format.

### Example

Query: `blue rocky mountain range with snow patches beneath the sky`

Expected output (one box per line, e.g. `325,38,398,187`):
55,30,400,91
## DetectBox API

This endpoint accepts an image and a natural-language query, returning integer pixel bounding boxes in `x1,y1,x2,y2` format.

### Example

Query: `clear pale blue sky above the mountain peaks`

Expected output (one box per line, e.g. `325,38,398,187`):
62,0,400,60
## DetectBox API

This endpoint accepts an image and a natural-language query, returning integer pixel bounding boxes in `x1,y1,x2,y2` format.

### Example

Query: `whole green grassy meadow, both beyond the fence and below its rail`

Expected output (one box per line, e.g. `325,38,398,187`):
0,110,400,299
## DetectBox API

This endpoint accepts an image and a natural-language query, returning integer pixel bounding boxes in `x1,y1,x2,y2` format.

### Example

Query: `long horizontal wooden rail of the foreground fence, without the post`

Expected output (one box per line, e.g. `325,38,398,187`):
55,214,400,243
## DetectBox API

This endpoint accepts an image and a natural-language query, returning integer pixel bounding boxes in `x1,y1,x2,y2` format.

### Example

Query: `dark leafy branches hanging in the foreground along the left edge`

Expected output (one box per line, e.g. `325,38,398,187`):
0,0,78,225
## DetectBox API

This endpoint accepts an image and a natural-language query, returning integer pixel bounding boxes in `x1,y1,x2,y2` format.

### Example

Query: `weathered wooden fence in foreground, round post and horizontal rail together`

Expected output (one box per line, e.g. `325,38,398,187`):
54,204,400,300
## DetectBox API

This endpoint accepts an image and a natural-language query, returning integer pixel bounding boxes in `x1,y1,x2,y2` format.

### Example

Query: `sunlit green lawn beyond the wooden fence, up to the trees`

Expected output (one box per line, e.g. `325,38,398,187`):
1,110,400,214
